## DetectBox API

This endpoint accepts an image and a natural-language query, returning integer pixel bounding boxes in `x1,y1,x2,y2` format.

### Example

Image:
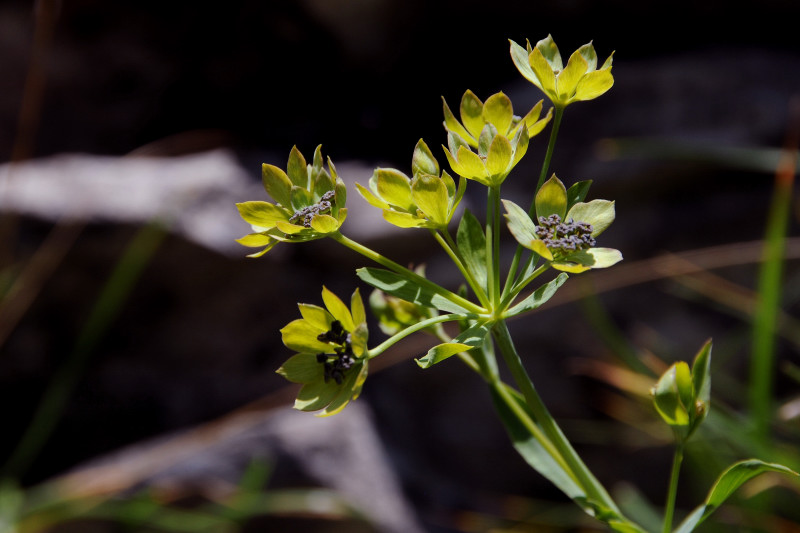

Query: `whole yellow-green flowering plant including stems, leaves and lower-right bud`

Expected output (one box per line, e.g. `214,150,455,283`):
238,36,792,533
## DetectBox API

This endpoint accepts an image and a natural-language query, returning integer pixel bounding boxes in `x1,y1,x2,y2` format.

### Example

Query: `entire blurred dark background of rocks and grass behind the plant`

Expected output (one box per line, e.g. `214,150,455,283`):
0,0,800,532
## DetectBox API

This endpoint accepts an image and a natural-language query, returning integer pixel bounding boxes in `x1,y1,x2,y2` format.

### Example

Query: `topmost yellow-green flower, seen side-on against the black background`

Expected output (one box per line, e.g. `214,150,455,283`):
510,35,614,107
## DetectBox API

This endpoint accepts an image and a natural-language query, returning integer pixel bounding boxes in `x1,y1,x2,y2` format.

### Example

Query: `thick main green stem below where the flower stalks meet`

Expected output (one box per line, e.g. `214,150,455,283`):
492,320,621,516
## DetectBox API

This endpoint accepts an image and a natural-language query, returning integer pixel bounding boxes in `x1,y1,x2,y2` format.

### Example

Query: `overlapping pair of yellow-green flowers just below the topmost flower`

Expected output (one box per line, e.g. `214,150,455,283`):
444,91,551,187
